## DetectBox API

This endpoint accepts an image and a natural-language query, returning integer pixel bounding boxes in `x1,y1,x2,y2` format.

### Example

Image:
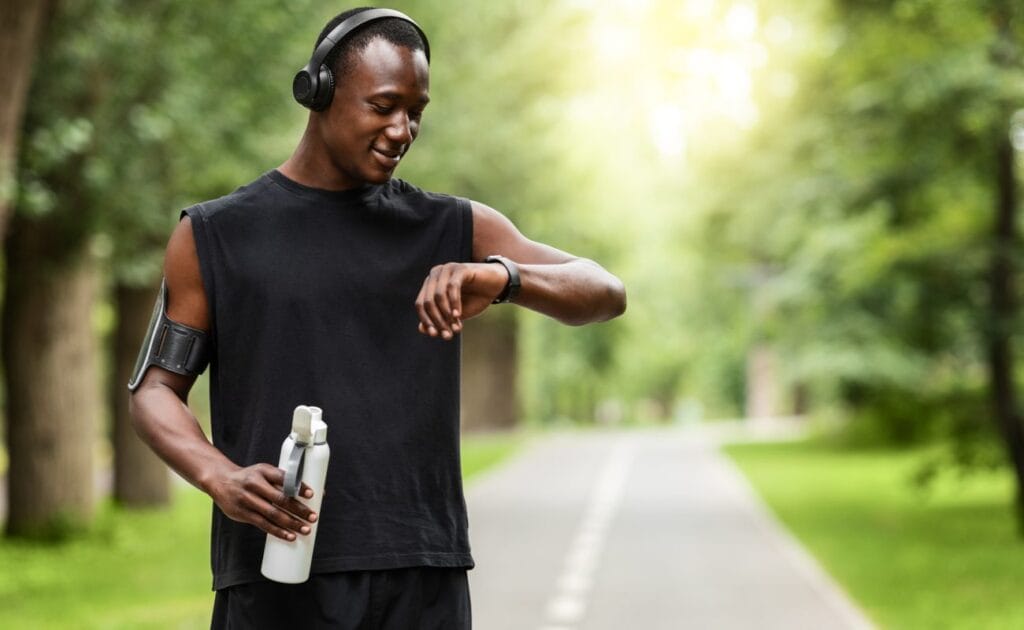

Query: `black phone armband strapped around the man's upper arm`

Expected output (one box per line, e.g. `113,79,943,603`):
128,280,210,391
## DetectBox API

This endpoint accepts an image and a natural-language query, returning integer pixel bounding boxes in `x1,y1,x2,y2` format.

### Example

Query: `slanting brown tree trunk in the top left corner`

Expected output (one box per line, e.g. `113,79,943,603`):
0,0,55,242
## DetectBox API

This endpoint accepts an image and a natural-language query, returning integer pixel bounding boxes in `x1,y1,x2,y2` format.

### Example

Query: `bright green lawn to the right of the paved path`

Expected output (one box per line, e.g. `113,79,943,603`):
726,443,1024,630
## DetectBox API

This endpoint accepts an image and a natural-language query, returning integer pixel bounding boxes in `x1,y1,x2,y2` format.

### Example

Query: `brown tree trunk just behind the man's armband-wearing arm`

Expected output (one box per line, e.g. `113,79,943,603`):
110,285,170,507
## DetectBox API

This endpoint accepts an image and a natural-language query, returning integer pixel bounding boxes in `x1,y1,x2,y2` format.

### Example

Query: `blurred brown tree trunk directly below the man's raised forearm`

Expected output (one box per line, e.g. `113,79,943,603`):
462,306,519,431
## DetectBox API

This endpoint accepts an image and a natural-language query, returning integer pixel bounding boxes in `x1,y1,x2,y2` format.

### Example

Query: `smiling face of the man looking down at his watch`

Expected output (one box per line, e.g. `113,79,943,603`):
319,38,430,187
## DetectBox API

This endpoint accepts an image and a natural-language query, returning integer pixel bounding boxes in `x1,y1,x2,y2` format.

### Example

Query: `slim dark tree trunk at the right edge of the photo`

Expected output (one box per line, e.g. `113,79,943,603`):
988,134,1024,533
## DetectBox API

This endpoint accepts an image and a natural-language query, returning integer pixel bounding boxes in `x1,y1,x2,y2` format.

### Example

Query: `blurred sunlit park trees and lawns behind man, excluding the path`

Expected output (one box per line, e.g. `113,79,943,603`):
0,0,1024,628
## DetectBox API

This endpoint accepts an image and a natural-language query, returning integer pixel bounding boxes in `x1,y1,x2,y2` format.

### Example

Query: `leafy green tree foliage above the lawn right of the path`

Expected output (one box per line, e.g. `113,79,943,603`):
688,0,1024,452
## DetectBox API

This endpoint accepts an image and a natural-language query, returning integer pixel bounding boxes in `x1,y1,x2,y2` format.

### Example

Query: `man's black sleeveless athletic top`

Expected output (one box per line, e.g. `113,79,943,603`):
182,171,473,589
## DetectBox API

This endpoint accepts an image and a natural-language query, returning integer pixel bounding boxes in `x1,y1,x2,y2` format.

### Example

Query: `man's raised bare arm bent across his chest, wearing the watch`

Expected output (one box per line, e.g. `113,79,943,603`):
416,202,626,339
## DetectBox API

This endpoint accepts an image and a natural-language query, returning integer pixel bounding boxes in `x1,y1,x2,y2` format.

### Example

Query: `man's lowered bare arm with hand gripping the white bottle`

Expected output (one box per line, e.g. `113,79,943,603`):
129,217,316,540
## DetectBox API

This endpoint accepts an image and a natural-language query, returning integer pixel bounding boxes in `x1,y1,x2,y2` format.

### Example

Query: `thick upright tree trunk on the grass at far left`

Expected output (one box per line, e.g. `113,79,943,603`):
2,0,102,536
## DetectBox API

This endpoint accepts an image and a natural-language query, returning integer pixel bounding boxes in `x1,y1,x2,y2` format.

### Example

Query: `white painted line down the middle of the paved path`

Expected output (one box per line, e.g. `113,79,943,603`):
541,445,633,630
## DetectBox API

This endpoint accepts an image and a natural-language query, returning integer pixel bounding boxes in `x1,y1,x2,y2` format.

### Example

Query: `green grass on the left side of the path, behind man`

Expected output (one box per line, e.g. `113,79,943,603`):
0,435,521,630
